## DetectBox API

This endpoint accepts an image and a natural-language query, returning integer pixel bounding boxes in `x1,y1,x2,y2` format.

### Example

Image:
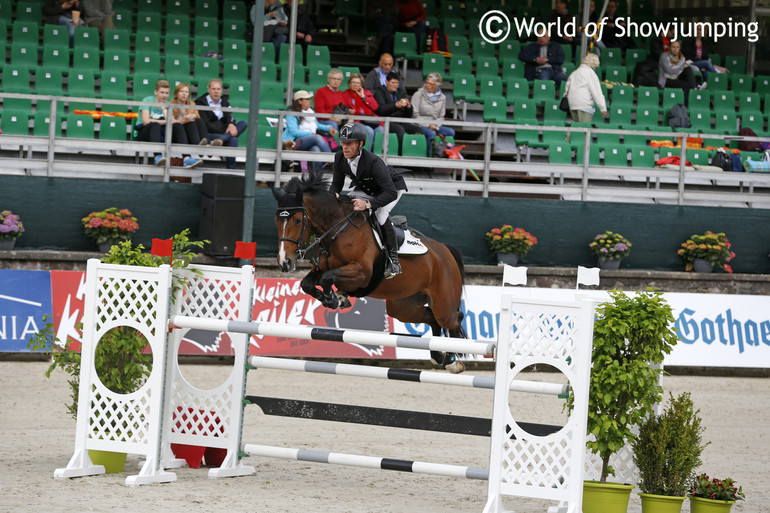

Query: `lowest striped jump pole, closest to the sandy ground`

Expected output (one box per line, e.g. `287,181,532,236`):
243,444,489,481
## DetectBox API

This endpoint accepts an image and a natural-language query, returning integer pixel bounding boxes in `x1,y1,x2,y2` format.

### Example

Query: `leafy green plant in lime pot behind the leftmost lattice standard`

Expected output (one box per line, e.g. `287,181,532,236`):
27,229,204,472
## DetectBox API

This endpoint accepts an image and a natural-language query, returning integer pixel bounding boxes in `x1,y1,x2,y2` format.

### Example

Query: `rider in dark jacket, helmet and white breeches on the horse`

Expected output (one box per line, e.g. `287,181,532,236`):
329,123,406,278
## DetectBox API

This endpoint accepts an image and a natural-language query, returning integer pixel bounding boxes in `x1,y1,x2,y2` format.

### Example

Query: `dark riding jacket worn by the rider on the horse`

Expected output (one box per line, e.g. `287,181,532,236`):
329,148,406,209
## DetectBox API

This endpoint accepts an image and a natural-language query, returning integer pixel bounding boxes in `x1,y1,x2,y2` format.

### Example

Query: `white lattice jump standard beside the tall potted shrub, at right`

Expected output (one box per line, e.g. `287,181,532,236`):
484,294,593,513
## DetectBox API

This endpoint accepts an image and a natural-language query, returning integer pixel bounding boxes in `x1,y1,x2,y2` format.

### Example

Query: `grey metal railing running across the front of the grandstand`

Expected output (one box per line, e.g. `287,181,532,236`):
0,93,770,208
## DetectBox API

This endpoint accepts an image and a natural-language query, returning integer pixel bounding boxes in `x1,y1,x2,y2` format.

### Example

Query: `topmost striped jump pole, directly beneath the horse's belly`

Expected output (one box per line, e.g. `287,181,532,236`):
169,315,495,355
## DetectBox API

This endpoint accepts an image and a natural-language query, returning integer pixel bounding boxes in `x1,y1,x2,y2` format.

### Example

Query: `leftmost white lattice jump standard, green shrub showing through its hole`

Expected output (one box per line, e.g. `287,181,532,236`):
54,259,176,485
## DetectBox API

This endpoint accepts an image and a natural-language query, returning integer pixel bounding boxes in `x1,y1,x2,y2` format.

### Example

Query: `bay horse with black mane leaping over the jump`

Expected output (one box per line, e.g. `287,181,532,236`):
273,171,467,373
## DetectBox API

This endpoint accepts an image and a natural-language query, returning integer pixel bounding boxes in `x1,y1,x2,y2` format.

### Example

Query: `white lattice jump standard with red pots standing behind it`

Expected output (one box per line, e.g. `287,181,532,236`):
164,265,255,477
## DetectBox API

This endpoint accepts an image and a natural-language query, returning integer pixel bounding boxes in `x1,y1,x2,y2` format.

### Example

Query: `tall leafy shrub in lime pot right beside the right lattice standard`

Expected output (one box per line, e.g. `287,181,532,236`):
567,289,677,513
